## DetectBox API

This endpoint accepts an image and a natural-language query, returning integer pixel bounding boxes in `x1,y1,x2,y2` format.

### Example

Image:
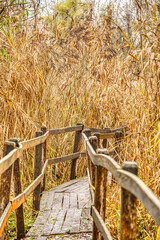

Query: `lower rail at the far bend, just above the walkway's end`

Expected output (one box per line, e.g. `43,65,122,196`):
48,152,86,165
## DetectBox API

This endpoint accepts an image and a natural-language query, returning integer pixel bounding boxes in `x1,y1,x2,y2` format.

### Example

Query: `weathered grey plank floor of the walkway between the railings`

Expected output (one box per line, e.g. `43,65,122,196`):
25,177,92,240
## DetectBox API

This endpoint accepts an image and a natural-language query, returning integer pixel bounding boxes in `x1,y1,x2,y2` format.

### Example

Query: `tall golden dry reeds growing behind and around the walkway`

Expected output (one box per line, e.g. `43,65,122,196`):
0,0,160,240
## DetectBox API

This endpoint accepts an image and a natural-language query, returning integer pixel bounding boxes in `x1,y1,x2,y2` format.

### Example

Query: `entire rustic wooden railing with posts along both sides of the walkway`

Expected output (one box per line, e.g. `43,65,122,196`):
0,124,160,240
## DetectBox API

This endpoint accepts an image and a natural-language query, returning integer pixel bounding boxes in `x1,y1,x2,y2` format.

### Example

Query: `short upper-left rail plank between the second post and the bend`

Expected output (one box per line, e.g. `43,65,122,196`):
21,131,49,150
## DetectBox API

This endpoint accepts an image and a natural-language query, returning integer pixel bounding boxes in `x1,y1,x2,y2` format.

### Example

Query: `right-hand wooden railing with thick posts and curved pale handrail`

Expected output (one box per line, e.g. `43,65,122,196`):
82,129,160,240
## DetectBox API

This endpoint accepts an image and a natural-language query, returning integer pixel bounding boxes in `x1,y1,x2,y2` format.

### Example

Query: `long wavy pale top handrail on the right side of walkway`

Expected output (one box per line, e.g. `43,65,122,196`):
82,133,160,224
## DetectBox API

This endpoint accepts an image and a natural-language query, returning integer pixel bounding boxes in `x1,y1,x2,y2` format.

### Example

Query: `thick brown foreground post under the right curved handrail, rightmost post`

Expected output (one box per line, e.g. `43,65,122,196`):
120,162,138,240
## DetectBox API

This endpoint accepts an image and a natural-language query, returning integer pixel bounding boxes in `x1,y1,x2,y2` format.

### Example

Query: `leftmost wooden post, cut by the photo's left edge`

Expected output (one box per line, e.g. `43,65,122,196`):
0,142,15,240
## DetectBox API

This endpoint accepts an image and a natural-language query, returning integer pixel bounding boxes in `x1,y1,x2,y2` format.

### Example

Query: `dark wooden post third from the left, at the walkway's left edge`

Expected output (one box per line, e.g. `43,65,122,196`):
33,131,43,210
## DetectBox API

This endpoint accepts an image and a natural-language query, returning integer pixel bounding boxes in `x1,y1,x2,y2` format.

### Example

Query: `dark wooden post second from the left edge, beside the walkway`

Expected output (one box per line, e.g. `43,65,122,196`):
9,138,25,240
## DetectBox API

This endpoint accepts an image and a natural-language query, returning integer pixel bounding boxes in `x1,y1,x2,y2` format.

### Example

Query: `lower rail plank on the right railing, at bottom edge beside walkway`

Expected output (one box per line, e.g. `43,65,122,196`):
91,206,112,240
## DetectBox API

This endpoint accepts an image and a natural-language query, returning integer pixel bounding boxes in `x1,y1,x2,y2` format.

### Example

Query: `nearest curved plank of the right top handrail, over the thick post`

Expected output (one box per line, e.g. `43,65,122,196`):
117,169,160,225
